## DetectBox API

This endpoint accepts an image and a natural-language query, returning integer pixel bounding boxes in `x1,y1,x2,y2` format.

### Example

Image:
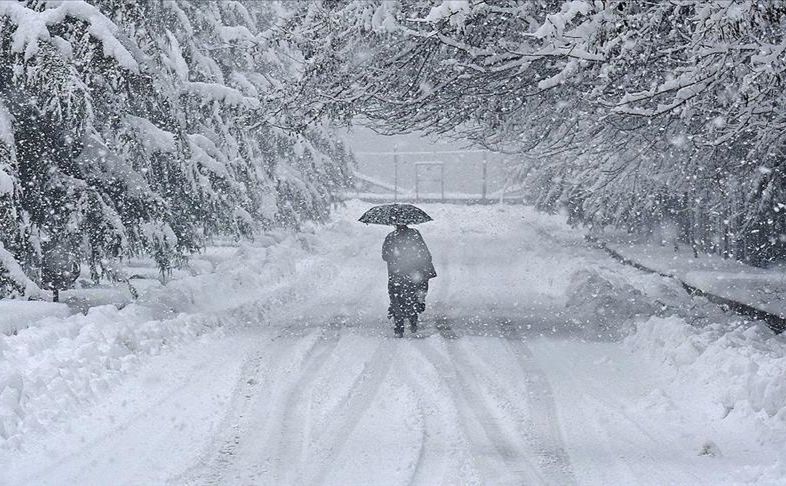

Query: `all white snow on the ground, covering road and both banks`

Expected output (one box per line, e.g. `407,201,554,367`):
0,201,786,485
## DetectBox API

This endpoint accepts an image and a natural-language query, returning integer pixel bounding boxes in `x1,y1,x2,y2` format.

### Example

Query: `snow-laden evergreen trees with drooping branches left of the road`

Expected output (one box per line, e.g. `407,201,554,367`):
0,0,351,295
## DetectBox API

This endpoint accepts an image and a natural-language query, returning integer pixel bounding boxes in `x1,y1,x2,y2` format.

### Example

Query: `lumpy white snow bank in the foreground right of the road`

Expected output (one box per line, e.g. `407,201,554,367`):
624,317,786,478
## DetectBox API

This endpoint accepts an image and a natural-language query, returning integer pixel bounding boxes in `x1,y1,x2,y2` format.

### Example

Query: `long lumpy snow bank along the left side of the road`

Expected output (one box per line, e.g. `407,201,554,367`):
0,228,332,448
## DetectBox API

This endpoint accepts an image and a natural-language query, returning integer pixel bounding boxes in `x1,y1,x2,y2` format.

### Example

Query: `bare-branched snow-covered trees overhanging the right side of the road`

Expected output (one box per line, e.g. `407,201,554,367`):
286,0,786,263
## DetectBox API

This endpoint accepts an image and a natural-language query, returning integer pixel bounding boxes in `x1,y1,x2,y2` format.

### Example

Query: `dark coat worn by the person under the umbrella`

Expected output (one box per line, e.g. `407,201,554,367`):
382,227,437,283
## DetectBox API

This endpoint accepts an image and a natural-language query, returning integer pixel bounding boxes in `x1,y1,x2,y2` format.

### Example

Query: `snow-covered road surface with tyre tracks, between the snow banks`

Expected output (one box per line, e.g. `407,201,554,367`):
0,203,772,485
